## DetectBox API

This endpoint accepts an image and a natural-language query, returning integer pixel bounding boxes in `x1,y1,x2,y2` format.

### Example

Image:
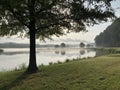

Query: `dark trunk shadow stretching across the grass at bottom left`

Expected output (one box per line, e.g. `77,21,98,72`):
0,72,29,90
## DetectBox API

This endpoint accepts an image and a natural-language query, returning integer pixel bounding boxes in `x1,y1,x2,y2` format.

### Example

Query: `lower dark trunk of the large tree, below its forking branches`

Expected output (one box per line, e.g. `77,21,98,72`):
27,26,38,73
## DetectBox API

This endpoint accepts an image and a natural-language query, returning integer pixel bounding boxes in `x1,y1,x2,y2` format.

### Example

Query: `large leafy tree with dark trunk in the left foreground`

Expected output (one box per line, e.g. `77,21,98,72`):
0,0,114,72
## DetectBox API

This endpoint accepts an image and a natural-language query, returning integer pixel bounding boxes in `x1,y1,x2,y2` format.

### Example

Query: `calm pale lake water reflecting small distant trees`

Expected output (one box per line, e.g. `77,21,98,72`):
0,48,96,71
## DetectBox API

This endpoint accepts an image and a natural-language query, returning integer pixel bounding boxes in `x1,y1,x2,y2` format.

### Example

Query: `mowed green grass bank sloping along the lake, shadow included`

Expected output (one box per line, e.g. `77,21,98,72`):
0,54,120,90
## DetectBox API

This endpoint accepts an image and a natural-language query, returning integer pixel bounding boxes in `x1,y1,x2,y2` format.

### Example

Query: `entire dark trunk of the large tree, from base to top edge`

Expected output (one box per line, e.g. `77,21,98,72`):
27,0,38,73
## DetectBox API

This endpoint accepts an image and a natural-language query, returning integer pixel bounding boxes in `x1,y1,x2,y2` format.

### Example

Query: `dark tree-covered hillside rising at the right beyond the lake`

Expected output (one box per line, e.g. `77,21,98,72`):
95,18,120,47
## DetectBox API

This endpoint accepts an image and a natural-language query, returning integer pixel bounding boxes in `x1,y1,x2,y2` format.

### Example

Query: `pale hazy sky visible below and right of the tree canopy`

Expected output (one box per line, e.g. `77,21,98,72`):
0,0,120,44
